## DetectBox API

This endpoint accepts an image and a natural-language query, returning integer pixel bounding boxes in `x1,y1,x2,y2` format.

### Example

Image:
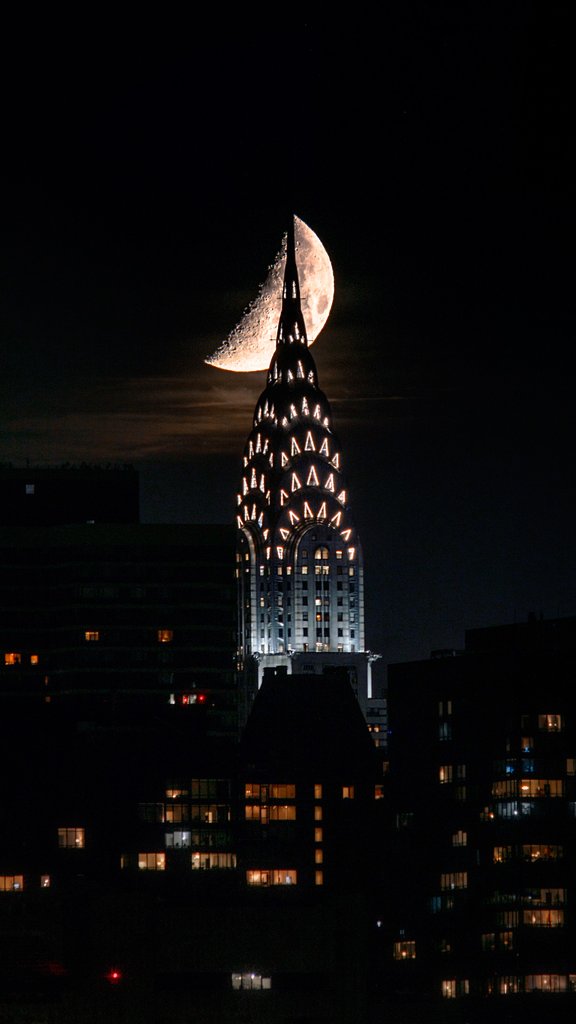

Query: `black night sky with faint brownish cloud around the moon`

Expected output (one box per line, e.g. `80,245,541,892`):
0,12,576,660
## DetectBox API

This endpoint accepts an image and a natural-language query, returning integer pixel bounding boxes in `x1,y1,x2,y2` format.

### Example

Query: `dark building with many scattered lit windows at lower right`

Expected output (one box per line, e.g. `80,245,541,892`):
382,618,576,1021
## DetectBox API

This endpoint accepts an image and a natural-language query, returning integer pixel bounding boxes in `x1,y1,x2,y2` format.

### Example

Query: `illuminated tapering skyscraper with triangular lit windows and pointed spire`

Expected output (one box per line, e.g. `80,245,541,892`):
237,222,381,729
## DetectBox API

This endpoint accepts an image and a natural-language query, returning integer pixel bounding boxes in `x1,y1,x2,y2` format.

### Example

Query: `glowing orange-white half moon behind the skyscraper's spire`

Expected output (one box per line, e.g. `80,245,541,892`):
204,216,334,373
